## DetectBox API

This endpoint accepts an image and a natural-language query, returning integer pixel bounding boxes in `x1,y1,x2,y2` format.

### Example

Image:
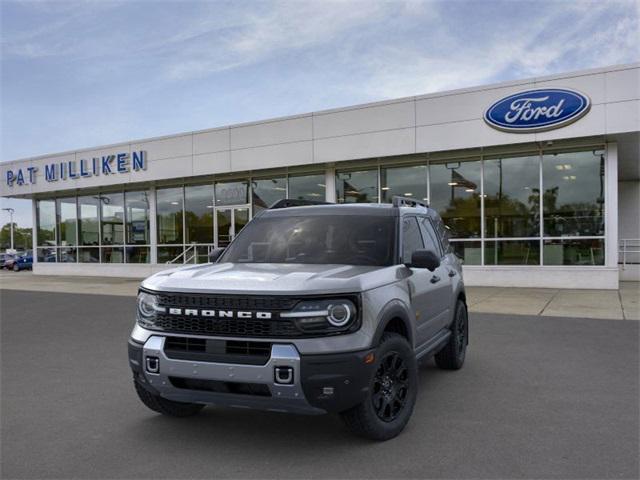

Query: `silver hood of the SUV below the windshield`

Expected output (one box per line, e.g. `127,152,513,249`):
142,263,399,295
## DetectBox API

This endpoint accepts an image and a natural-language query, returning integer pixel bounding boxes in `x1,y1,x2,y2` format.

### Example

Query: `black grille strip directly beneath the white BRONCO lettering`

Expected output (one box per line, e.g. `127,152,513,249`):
154,314,304,337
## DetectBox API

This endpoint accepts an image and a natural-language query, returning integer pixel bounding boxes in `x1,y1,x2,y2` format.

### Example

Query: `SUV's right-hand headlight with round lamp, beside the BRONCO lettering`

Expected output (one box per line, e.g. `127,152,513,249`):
280,298,358,334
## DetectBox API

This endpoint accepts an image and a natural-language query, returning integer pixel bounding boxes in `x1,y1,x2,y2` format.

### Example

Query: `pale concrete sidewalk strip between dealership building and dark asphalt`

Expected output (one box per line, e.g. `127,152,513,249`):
0,271,640,320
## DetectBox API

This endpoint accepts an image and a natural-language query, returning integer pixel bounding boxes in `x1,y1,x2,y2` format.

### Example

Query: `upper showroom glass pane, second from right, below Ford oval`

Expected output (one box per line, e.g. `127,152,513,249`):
484,155,540,238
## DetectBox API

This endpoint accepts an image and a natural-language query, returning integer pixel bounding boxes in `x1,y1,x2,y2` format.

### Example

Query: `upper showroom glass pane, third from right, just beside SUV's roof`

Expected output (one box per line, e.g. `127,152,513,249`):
429,160,481,238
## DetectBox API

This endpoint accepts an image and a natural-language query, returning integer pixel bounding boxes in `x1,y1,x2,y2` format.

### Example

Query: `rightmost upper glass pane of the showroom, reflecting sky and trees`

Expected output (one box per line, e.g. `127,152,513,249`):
542,151,604,237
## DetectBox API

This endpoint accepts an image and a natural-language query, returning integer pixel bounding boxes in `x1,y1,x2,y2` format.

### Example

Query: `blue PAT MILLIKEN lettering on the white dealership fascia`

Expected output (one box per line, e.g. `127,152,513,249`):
4,150,147,187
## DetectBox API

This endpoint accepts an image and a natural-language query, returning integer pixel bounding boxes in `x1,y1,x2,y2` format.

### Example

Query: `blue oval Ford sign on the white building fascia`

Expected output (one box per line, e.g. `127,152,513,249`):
484,88,591,133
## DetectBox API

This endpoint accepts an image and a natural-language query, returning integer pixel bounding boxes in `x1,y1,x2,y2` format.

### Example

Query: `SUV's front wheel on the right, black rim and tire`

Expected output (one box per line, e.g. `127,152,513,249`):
340,333,418,441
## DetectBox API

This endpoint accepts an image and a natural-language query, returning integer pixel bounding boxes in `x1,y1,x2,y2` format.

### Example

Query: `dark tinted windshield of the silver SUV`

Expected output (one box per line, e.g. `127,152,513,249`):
220,215,395,266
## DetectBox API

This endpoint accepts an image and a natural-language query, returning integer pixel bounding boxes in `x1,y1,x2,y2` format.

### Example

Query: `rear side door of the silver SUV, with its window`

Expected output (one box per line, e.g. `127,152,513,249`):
419,216,453,330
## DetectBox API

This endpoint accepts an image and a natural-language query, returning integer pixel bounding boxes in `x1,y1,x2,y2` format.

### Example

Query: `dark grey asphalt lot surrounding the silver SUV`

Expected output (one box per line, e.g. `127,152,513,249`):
0,290,640,478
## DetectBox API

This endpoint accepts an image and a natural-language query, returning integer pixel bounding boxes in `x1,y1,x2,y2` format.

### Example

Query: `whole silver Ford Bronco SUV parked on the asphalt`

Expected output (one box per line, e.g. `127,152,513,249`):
129,197,468,440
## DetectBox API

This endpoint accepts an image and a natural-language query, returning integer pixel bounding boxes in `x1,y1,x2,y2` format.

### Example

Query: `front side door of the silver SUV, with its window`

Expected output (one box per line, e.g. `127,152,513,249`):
402,216,439,350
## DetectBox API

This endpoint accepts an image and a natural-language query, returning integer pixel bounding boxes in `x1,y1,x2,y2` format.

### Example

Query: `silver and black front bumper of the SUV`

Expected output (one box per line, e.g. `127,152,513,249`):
129,335,372,415
